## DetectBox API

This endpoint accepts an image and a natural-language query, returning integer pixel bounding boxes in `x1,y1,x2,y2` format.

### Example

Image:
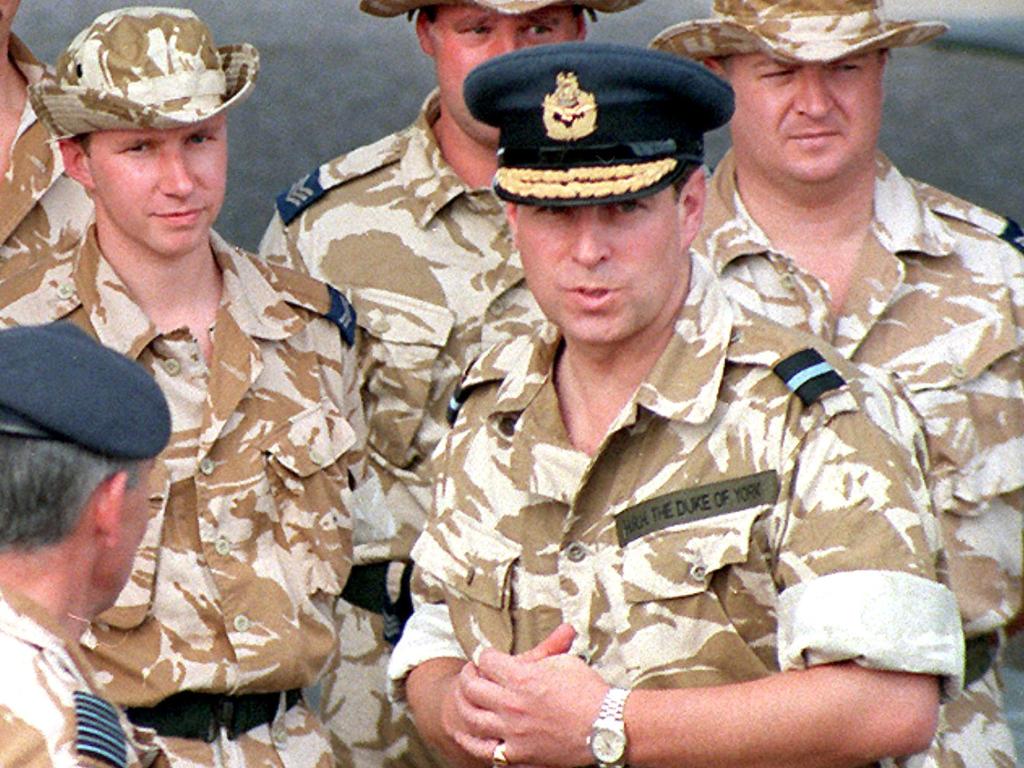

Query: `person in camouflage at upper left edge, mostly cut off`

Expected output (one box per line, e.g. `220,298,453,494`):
0,0,92,279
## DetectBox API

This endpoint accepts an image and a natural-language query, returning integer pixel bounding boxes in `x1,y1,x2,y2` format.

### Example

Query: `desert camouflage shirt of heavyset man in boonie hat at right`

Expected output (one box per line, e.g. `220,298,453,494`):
695,156,1024,636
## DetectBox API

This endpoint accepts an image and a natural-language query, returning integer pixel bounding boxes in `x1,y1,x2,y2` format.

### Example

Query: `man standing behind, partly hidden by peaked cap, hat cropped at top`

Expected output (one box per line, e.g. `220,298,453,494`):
260,0,639,768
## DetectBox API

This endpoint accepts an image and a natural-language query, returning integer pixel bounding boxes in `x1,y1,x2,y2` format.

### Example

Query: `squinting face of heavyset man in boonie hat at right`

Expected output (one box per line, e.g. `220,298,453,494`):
713,51,886,191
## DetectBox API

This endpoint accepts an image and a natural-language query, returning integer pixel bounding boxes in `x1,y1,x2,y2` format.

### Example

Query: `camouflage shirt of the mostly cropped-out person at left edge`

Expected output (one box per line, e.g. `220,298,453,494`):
0,36,92,279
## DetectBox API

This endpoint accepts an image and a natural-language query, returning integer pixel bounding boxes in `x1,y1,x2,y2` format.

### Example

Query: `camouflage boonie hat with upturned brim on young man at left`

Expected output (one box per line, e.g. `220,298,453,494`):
29,7,259,138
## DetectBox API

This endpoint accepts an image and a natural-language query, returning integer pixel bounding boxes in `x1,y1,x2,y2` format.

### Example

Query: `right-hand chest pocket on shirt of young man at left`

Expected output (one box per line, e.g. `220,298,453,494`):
263,401,355,595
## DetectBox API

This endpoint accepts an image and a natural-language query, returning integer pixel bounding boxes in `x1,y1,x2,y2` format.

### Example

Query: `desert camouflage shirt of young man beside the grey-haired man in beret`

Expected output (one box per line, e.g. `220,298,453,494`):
0,230,364,707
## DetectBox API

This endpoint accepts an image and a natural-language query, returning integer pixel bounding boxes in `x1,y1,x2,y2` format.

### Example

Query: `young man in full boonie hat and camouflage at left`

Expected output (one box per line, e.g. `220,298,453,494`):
8,7,364,768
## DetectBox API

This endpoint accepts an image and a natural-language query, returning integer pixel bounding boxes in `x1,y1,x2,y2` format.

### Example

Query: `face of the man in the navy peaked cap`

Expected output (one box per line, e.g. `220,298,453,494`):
508,172,705,356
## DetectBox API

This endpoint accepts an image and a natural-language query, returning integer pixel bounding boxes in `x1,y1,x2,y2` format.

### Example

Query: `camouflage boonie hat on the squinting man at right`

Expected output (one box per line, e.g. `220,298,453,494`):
651,0,948,63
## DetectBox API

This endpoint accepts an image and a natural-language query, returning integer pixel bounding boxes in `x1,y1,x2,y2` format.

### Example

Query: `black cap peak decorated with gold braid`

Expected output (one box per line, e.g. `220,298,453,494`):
494,157,698,208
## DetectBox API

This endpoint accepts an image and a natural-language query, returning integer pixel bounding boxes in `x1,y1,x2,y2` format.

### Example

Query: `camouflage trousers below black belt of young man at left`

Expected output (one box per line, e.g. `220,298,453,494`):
153,701,332,768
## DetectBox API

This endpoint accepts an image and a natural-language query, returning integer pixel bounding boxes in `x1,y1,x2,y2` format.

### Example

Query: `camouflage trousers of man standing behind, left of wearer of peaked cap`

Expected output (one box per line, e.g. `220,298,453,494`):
321,601,443,768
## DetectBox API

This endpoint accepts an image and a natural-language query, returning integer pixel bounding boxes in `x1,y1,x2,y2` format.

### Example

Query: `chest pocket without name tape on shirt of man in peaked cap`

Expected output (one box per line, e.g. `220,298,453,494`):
413,521,520,658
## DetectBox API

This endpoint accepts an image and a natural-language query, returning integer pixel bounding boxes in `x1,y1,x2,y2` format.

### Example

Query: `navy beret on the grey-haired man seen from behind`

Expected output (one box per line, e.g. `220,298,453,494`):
0,323,171,459
